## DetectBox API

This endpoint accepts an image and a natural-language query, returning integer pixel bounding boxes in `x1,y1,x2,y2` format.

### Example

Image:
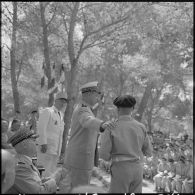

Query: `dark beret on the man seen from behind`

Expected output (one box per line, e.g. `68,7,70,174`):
113,95,136,108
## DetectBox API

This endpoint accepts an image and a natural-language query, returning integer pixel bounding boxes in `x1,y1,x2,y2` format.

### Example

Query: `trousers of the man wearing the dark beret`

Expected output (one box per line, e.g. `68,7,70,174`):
109,161,143,193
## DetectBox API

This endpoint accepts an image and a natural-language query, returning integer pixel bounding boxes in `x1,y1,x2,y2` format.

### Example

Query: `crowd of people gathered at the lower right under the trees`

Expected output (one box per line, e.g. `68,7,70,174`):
144,130,193,193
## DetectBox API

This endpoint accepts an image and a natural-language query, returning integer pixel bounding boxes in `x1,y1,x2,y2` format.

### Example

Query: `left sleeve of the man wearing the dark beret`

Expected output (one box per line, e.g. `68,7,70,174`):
99,130,112,161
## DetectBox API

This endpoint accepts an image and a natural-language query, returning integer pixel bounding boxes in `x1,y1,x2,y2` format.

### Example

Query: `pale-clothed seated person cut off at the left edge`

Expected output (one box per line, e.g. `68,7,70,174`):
1,149,15,194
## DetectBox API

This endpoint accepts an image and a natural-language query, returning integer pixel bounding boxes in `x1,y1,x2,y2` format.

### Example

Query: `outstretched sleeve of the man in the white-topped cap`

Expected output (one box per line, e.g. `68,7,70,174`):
78,107,103,131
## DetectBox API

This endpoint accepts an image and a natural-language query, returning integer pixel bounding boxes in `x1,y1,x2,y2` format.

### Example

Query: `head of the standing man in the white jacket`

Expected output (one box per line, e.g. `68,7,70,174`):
54,92,68,111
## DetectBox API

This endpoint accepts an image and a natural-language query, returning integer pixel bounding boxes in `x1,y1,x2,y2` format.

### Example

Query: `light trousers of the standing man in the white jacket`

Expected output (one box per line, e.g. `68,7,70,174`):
37,151,59,177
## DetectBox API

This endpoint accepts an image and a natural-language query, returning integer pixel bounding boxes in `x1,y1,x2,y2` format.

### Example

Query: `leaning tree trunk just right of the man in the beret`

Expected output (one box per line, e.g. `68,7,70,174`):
135,81,153,121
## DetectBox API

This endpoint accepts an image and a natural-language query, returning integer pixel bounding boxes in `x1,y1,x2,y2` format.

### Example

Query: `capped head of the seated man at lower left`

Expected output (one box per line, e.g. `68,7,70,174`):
8,129,38,157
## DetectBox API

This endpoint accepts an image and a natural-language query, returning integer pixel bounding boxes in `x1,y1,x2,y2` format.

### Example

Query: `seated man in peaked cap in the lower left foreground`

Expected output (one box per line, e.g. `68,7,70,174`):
8,128,65,194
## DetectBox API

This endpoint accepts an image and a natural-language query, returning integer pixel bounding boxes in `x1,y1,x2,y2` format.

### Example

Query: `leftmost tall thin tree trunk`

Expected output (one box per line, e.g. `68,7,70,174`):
10,2,20,112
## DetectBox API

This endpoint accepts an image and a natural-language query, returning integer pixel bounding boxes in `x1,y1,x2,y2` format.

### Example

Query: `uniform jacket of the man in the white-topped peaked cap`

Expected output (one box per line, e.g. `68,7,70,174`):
64,104,103,170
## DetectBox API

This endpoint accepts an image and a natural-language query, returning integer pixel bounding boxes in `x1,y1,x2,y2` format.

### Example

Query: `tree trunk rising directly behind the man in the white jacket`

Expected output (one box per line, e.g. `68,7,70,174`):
40,2,55,106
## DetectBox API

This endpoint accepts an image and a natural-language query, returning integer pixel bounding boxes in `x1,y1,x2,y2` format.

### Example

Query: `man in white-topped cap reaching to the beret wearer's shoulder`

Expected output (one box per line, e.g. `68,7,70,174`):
64,81,114,188
